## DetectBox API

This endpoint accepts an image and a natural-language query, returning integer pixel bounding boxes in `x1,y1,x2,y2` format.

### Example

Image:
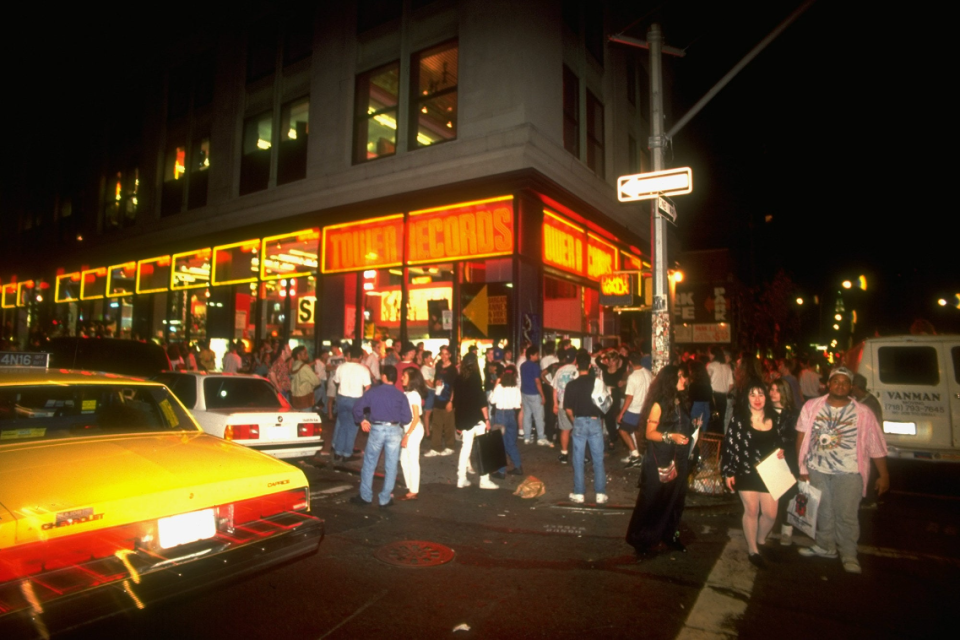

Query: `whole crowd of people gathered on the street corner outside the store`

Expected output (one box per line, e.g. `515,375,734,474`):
168,340,889,573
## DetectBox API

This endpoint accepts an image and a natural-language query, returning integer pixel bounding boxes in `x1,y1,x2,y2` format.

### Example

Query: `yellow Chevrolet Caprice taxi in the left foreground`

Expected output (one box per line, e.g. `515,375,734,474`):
0,354,324,637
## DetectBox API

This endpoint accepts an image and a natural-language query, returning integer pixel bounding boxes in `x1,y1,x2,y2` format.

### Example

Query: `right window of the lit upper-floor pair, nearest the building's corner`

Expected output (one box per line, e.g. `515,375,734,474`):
410,42,459,149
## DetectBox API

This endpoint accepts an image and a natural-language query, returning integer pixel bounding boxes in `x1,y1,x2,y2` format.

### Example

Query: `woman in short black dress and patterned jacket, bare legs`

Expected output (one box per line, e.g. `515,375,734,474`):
721,378,790,567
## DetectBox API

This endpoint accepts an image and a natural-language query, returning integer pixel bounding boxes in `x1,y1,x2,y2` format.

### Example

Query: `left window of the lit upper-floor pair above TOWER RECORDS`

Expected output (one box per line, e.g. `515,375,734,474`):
353,62,400,163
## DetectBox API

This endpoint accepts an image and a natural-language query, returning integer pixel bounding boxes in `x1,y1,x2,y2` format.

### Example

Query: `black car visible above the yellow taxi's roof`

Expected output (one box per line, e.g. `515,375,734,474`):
41,336,172,378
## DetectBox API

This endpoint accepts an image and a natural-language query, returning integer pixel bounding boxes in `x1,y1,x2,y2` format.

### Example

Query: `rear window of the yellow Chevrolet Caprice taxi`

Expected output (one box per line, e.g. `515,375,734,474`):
0,384,196,445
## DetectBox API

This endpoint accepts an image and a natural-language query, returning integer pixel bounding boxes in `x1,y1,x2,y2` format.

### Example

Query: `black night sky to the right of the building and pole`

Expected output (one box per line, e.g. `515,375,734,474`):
629,0,960,332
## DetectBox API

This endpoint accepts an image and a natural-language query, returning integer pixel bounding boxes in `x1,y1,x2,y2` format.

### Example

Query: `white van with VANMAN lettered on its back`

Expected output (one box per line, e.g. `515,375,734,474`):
846,335,960,462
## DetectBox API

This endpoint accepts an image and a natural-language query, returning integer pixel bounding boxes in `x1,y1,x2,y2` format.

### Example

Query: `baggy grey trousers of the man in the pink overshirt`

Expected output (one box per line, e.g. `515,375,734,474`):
810,469,863,560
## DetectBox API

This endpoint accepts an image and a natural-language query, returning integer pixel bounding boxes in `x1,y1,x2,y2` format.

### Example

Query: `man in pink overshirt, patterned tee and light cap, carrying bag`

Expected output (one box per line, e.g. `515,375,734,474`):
797,367,890,573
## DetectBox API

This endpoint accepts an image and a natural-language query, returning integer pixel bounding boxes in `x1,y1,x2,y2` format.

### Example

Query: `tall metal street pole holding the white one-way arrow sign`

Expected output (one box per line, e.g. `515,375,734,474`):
647,23,670,374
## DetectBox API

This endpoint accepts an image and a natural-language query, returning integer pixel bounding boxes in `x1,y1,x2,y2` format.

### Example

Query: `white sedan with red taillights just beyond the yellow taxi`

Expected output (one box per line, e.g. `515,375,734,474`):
154,371,323,458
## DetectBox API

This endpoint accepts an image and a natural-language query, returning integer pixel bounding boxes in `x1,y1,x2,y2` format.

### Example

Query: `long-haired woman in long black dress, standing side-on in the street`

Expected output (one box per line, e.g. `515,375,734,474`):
627,365,695,557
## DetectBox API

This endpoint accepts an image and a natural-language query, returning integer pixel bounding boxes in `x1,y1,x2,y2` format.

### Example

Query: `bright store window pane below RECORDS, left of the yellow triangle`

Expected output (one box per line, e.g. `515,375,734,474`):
407,263,454,355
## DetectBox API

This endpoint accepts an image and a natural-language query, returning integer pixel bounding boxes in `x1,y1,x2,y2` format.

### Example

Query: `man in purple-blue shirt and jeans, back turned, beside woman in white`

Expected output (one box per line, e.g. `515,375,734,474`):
350,364,413,508
